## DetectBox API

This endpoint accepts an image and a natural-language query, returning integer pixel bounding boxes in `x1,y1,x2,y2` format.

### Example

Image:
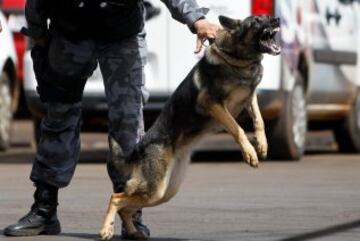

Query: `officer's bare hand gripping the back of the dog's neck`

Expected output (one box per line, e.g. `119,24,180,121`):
194,19,220,54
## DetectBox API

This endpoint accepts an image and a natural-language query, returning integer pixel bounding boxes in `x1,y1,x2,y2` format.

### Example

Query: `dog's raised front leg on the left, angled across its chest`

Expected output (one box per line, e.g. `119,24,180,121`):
207,103,259,167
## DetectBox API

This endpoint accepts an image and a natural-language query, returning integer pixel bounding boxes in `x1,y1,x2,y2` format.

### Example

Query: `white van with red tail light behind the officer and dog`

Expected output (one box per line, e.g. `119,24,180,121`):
24,0,360,159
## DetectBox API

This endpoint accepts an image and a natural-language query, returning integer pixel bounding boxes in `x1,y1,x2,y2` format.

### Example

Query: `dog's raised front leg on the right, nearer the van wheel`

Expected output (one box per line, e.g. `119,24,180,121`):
246,93,268,159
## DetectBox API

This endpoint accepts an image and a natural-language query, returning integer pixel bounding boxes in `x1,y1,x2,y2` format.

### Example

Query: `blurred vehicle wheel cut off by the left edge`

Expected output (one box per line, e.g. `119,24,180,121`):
0,72,13,151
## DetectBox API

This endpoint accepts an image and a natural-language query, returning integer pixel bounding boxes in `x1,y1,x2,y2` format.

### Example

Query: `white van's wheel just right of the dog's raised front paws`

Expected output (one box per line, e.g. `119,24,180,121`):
266,76,307,160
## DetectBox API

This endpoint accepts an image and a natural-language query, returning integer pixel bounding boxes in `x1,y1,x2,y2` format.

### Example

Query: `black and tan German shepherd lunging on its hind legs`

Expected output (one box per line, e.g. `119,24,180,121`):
100,16,280,240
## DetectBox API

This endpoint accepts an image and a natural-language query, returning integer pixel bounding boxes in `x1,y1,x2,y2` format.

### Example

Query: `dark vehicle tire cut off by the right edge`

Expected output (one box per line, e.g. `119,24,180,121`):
334,91,360,153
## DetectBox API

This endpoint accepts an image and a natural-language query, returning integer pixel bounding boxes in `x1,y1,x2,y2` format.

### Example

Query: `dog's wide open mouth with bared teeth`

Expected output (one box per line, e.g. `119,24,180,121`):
259,26,281,55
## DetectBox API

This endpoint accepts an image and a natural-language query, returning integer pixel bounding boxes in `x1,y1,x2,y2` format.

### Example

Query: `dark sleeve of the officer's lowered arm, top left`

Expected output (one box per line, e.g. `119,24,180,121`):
22,0,51,38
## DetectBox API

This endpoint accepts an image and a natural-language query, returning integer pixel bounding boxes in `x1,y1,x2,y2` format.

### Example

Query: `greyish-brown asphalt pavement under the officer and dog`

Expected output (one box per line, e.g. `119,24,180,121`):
0,122,360,241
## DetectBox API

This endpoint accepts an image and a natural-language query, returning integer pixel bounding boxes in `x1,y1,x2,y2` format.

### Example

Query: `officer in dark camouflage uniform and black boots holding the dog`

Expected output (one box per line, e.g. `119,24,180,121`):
4,0,218,238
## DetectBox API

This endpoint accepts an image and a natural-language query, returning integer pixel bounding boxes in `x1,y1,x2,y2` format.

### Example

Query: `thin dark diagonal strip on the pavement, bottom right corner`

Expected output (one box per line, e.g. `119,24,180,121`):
279,220,360,241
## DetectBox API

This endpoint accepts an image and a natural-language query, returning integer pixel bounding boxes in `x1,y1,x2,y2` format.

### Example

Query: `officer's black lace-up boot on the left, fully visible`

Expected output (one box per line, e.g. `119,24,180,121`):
4,183,61,236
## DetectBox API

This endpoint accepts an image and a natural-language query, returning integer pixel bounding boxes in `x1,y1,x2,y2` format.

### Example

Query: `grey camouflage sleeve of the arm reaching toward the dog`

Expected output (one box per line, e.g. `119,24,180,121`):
161,0,209,32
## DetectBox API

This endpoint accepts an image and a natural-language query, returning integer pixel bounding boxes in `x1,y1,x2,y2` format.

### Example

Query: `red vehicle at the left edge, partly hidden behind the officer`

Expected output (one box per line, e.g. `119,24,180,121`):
0,0,27,112
